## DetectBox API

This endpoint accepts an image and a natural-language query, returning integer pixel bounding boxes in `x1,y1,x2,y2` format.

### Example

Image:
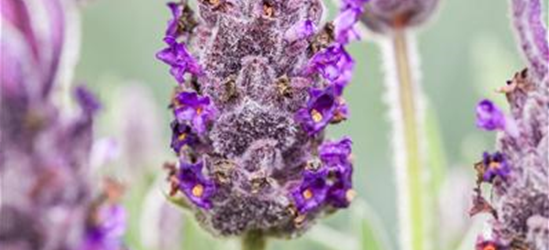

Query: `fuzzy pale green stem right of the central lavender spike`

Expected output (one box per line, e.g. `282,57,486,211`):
392,29,426,250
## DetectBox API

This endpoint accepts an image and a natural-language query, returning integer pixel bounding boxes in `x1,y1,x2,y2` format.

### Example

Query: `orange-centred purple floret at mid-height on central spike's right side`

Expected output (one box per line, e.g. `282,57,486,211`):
295,87,341,135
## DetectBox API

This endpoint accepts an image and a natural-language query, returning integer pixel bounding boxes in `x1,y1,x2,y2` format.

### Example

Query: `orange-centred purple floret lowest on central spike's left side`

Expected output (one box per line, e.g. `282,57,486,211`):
177,161,216,209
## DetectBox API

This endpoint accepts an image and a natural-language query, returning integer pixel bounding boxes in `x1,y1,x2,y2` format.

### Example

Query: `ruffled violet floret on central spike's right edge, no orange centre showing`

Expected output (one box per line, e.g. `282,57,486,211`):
305,44,355,92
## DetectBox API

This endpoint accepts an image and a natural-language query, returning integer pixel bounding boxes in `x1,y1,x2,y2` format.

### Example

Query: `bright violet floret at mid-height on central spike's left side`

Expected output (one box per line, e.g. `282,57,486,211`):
174,92,215,134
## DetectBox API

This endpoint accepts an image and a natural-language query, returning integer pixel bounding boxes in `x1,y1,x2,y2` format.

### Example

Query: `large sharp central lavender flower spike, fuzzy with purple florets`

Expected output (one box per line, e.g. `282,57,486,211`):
157,0,366,235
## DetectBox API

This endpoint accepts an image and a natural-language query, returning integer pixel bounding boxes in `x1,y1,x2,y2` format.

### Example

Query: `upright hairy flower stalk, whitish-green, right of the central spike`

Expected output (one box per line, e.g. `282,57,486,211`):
384,28,428,250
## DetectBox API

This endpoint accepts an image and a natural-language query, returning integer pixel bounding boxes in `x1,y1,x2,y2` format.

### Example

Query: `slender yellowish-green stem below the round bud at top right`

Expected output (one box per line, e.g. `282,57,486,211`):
393,29,426,250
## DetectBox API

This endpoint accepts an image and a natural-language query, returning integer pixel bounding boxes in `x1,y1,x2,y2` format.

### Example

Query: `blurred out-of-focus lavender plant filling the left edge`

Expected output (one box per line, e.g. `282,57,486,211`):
0,0,125,250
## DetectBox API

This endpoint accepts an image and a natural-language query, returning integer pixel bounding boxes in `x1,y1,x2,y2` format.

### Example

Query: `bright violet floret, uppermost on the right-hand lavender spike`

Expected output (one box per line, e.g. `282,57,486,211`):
477,100,505,130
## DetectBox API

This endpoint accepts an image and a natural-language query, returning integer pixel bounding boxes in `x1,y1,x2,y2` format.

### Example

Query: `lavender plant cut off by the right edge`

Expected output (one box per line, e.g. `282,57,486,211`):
471,0,549,250
